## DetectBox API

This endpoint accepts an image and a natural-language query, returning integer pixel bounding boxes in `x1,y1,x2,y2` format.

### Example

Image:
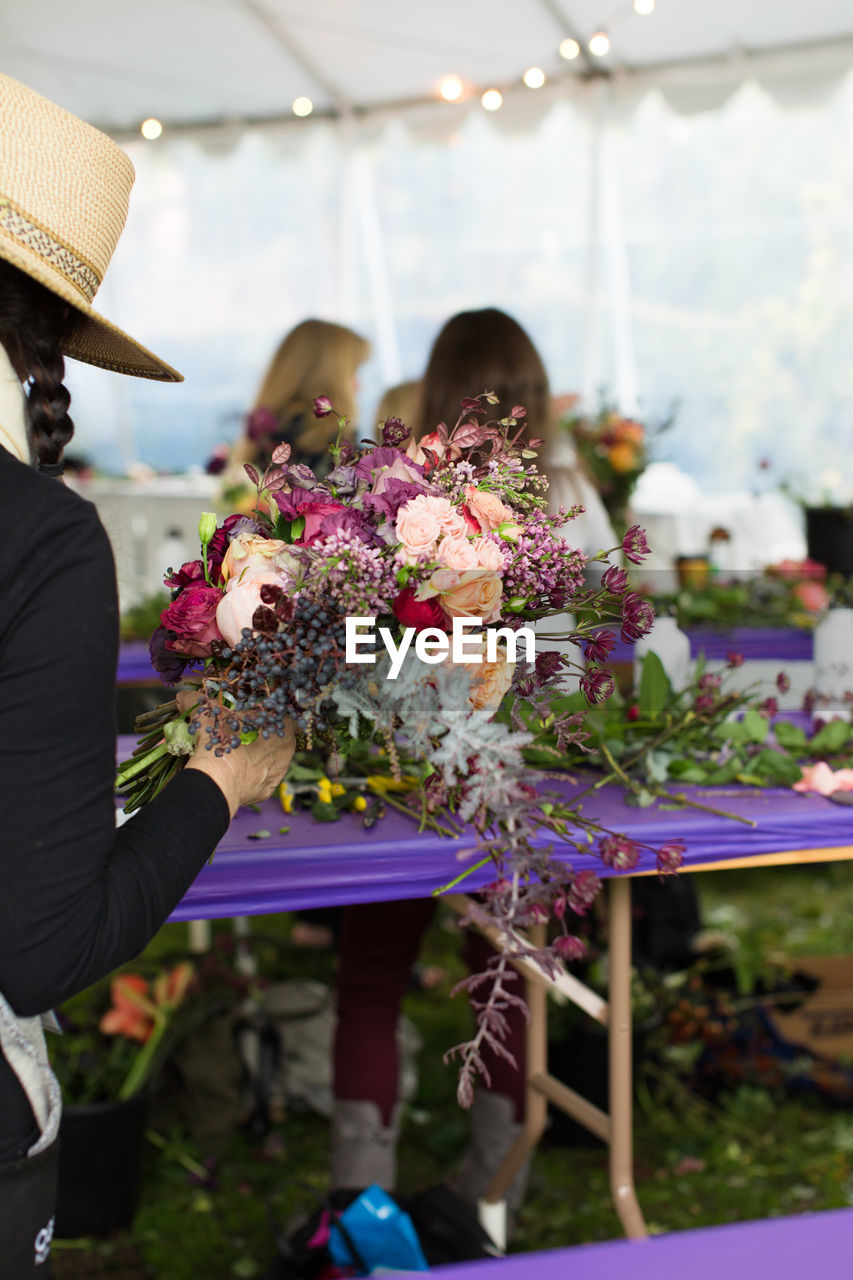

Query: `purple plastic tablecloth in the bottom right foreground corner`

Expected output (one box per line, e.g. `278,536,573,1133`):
422,1208,853,1280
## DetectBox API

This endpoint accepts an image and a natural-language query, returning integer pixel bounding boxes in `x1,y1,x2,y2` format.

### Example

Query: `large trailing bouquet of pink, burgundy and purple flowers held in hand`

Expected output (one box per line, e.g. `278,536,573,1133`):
118,393,671,1101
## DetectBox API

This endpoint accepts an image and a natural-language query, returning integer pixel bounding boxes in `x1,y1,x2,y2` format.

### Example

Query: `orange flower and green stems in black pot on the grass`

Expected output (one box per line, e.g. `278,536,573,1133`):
51,963,195,1238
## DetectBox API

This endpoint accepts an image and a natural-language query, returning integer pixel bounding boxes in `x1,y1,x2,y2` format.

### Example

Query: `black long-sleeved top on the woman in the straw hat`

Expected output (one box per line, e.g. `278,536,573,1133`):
0,465,229,1016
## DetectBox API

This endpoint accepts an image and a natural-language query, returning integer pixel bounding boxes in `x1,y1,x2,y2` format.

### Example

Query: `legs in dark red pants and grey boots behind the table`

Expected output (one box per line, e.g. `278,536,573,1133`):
332,899,526,1211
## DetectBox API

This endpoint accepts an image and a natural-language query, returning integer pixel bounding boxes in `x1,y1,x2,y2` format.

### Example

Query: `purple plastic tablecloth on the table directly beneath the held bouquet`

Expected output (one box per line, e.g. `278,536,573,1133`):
119,739,853,920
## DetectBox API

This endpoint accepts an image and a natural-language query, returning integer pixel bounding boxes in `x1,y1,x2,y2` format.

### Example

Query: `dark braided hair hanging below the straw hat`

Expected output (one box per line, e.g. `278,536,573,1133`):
0,260,74,463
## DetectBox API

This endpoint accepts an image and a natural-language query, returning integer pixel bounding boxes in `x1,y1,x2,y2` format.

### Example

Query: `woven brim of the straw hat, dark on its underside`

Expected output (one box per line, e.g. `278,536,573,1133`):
0,237,183,383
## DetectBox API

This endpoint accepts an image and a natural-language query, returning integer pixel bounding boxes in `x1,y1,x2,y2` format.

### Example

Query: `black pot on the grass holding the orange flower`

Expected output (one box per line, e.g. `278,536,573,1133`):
55,1094,147,1239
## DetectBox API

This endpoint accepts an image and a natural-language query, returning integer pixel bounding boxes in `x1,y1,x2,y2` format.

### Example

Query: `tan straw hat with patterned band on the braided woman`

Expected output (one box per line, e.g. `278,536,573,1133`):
0,74,182,383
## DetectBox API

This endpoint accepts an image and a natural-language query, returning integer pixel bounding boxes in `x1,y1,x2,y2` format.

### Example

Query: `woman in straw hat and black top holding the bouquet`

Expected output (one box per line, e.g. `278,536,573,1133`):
0,74,292,1280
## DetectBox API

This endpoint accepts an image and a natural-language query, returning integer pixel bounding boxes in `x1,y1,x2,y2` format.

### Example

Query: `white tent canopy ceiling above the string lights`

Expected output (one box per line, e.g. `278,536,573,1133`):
0,0,853,133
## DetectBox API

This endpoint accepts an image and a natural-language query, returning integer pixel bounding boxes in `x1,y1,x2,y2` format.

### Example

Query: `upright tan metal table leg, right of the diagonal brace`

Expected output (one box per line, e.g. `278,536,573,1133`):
608,877,648,1239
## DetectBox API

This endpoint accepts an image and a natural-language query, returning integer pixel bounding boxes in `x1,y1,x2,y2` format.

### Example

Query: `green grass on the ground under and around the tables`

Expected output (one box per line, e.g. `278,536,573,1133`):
55,864,853,1280
